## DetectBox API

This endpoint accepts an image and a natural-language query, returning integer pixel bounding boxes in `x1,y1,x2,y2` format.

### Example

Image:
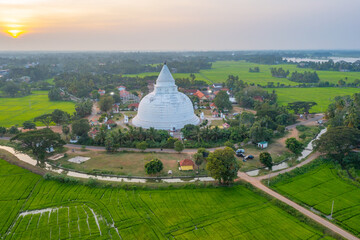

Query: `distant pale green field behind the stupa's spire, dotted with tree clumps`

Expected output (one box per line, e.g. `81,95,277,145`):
128,61,360,86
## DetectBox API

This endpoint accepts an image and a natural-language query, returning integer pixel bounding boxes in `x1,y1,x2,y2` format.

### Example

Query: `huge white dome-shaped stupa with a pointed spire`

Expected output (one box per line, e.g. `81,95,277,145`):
132,63,200,130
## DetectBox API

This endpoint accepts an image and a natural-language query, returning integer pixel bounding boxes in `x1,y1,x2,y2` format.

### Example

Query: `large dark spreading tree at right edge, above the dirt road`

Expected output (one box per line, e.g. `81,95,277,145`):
315,126,360,169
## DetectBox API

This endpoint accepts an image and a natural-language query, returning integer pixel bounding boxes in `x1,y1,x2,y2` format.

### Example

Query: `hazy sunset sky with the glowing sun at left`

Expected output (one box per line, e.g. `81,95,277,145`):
0,0,360,51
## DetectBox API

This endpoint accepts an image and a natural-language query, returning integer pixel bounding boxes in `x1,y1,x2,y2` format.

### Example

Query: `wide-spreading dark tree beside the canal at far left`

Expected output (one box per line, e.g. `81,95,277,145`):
11,128,65,164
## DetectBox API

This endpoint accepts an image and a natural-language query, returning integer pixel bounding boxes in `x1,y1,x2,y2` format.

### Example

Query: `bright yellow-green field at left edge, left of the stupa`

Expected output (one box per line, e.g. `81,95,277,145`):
0,91,75,127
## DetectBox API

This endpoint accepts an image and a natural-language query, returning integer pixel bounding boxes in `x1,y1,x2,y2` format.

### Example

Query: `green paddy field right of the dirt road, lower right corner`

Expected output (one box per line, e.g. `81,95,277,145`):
272,163,360,237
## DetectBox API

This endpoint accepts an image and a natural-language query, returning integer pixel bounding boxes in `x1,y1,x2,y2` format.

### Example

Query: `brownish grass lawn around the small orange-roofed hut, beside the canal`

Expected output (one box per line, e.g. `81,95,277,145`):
59,151,206,176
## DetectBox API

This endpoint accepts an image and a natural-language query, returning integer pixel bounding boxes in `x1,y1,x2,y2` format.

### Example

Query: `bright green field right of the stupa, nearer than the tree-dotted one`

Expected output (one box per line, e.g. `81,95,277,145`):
268,88,360,112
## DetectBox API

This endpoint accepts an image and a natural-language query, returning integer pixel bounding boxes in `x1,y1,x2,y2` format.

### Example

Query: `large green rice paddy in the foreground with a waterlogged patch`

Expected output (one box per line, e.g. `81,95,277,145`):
0,160,331,239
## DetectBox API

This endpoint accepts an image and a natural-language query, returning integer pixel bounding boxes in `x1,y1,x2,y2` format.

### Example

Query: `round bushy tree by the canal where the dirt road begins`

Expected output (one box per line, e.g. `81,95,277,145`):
206,147,240,184
